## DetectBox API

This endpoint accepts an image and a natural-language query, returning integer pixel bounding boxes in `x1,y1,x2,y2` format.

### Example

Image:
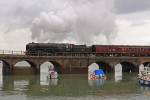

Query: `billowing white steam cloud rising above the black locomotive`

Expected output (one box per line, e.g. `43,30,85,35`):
31,0,116,44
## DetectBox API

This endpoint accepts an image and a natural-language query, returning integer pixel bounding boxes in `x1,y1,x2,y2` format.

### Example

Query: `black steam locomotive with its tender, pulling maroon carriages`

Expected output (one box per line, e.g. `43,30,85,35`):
26,43,91,56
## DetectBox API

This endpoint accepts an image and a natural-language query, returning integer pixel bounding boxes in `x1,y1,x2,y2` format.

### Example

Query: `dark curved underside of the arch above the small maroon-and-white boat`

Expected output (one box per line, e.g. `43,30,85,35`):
40,60,62,74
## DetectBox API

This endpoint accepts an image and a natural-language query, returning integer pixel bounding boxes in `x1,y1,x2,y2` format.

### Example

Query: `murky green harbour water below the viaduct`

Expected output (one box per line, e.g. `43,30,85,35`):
0,73,150,100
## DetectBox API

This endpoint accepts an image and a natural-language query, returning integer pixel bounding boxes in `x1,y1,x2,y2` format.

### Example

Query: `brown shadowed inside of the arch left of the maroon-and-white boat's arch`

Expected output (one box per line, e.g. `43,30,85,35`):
13,59,38,75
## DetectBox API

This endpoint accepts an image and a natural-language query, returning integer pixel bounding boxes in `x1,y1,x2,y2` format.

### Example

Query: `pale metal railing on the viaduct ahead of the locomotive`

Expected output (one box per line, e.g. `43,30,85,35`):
0,50,25,55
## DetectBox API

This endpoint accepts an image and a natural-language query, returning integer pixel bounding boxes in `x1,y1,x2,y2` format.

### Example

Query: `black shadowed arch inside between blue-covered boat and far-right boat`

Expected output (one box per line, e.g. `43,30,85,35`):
120,61,139,72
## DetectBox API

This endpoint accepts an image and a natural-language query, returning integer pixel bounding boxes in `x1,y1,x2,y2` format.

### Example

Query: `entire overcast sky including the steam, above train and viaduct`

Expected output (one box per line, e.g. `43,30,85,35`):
0,0,150,51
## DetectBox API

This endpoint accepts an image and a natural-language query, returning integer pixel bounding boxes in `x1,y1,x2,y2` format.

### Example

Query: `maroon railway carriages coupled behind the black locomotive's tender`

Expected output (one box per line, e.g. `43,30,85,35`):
92,45,150,56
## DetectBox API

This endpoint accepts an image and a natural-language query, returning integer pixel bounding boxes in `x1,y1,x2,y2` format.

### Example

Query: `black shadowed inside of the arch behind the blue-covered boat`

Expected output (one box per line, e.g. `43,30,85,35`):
95,61,112,73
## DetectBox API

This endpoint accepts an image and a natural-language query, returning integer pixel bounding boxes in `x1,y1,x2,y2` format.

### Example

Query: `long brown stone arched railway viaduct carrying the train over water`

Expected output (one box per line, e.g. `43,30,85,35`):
0,54,150,75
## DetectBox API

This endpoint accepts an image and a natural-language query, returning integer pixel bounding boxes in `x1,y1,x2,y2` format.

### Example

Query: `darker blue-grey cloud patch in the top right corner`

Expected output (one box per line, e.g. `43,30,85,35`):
114,0,150,14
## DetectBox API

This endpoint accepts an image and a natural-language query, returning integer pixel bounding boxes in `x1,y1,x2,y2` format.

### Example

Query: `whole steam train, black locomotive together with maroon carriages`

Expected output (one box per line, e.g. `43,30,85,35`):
25,42,150,57
